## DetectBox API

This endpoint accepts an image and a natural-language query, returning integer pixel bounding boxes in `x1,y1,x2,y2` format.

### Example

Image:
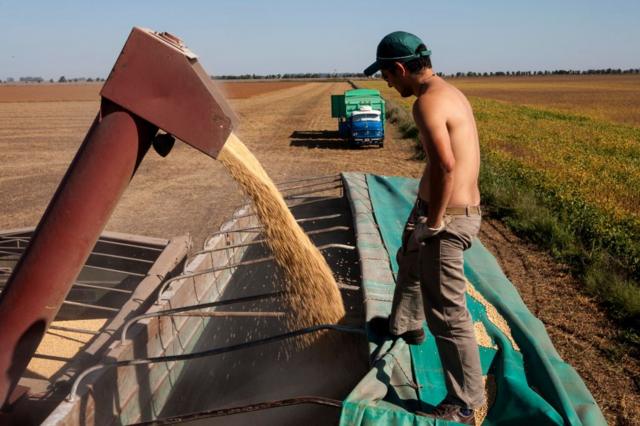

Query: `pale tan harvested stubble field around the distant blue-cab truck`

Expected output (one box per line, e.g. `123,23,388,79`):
0,83,422,246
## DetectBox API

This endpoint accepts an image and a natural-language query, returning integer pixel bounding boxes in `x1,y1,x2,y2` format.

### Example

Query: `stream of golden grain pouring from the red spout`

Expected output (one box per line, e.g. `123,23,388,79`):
218,133,345,344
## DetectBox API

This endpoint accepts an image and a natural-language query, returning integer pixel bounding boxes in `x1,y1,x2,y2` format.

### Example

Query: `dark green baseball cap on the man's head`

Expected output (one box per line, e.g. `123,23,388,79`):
364,31,431,76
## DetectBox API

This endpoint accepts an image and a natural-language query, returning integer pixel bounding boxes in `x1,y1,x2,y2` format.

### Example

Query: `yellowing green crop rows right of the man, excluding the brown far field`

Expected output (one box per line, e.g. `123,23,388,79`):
363,77,640,320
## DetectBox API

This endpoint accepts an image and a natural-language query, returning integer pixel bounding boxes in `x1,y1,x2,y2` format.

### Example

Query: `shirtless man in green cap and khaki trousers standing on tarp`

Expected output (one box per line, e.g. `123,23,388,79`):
365,31,484,424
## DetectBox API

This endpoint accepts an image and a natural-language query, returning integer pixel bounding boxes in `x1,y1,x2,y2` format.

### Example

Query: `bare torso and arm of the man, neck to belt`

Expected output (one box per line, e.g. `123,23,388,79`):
413,74,480,225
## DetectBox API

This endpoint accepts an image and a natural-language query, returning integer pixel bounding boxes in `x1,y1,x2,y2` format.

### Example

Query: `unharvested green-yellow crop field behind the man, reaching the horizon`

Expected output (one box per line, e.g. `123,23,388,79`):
358,76,640,323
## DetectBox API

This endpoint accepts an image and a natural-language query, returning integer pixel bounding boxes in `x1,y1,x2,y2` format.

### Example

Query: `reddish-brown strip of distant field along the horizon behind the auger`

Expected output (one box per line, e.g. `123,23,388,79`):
0,81,304,103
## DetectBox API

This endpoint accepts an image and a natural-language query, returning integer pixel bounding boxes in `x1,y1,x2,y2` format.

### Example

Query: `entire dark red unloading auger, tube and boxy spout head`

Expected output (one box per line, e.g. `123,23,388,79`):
0,28,234,405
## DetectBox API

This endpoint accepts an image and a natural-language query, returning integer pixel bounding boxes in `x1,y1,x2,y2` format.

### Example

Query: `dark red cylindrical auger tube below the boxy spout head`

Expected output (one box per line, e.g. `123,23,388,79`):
0,104,157,404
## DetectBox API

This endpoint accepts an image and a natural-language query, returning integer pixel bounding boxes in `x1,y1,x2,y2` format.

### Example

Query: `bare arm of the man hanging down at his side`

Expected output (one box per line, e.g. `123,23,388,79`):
413,98,456,228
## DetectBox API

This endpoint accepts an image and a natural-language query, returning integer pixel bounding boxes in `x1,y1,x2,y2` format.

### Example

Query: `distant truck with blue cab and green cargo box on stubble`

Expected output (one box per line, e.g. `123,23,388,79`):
331,89,385,148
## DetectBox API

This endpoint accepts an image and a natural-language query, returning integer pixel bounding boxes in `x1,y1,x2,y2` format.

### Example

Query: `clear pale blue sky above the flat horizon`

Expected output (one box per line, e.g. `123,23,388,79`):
0,0,640,80
